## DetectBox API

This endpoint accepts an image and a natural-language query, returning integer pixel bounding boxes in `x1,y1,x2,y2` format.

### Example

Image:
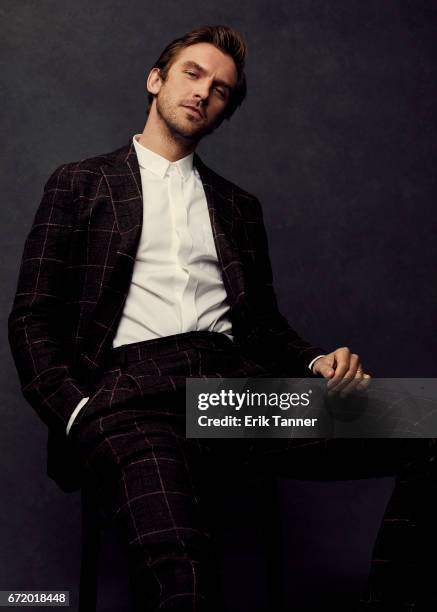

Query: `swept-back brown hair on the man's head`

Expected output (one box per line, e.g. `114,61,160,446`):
147,25,247,119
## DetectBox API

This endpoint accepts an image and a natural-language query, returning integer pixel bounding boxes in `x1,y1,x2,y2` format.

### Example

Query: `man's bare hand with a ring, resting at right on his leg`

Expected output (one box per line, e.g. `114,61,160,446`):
313,346,370,397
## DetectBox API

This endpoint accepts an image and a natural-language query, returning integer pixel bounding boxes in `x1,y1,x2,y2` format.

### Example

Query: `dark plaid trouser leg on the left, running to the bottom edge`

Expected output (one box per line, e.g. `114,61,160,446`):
75,372,225,612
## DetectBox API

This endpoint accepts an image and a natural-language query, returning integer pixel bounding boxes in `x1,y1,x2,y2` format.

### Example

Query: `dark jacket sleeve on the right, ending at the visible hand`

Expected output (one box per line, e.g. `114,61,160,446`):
238,198,329,376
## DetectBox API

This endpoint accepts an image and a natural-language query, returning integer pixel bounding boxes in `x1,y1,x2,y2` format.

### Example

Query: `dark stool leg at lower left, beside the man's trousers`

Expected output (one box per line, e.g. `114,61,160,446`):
79,490,100,612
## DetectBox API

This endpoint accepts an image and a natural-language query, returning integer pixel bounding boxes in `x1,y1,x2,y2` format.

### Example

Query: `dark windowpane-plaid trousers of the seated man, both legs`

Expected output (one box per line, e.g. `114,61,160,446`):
70,332,437,612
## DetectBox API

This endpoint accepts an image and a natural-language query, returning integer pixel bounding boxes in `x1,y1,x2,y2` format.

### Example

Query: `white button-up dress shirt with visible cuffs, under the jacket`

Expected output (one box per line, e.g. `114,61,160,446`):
67,134,324,435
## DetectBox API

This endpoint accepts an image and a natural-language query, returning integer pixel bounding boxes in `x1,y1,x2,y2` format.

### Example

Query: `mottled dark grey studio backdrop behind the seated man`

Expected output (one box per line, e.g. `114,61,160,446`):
0,0,437,610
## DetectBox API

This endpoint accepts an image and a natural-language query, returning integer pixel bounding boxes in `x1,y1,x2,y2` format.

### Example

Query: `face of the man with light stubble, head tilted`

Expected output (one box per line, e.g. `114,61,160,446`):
148,43,237,141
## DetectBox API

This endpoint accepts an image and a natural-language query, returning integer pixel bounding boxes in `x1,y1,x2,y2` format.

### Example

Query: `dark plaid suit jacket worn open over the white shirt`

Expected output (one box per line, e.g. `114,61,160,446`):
9,143,324,490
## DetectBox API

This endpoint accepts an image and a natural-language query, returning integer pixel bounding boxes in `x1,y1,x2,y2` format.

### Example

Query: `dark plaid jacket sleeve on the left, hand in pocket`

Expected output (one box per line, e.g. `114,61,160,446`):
8,165,89,430
